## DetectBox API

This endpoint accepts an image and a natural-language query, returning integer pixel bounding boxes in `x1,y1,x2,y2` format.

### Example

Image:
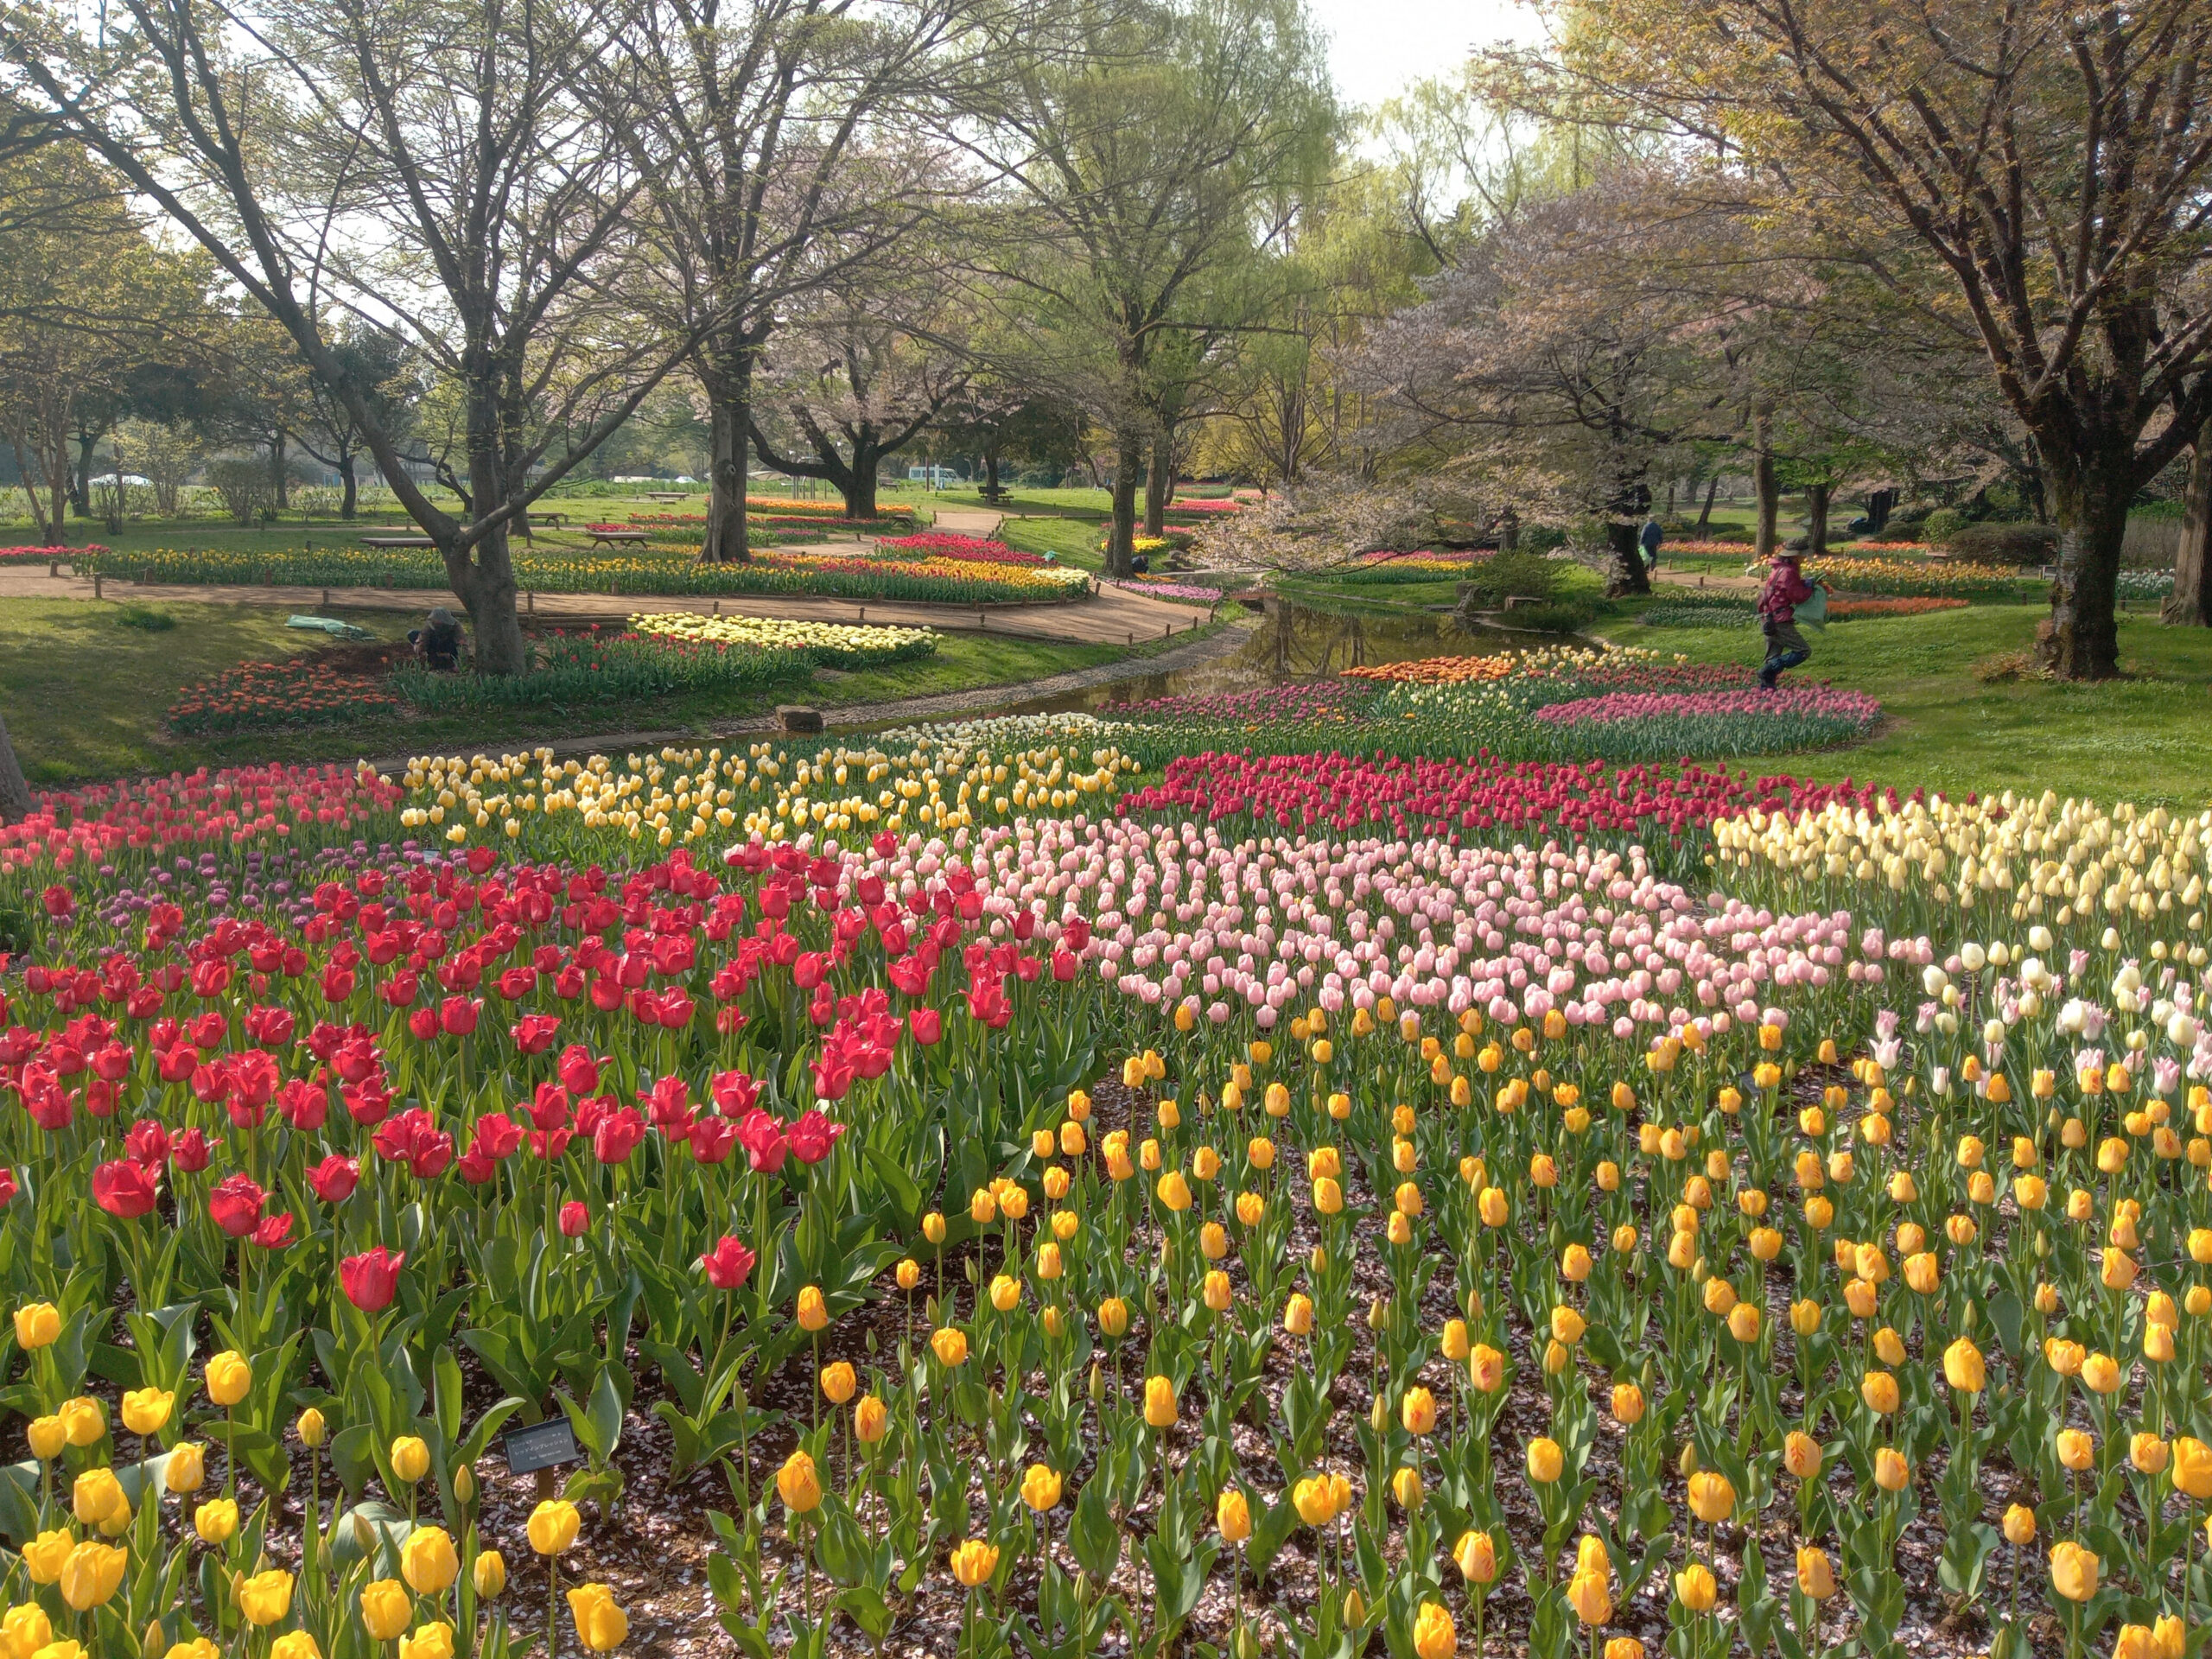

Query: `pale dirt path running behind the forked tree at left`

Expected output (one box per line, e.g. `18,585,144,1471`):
0,570,1205,646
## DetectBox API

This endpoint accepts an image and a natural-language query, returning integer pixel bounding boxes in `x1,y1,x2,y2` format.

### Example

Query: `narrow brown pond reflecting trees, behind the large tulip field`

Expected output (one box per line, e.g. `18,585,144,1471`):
995,600,1531,715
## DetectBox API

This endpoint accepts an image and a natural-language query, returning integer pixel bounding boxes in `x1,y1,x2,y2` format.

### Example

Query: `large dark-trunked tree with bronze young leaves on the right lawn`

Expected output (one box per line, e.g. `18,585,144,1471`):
1566,0,2212,679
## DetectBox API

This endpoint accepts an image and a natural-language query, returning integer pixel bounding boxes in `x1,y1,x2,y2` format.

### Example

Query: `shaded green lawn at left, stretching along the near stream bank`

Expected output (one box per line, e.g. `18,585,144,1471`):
0,600,1190,785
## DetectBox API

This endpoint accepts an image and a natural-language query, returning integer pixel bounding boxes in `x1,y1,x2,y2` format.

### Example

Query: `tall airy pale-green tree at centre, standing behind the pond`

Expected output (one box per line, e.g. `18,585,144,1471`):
949,0,1336,575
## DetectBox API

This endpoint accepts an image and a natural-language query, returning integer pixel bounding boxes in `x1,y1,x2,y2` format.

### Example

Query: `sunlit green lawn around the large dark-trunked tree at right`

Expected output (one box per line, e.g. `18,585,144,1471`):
1599,606,2212,810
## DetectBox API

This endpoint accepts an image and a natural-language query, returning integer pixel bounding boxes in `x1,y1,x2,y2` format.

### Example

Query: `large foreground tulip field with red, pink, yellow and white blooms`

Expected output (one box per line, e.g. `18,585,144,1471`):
0,652,2212,1659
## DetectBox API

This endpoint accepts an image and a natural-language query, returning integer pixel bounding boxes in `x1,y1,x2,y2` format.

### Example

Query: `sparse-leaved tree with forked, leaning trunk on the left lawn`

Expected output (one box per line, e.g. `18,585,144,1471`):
0,0,695,675
